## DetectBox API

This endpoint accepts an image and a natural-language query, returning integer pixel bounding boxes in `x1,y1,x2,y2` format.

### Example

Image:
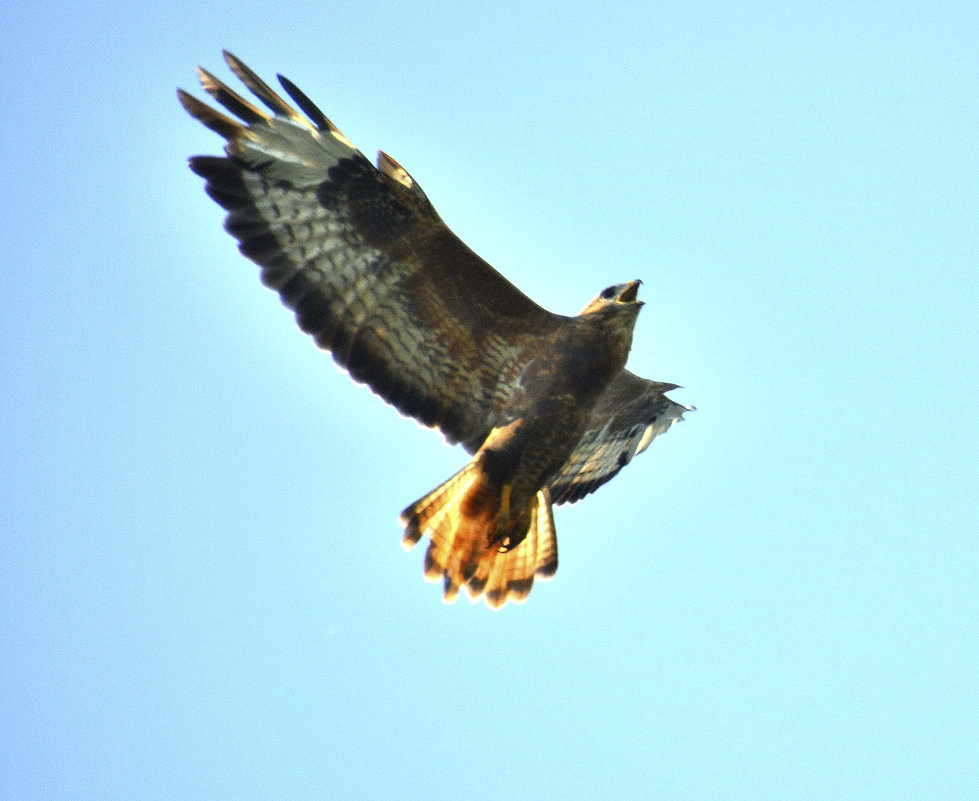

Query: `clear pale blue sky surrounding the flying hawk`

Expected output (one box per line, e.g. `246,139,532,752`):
0,0,979,801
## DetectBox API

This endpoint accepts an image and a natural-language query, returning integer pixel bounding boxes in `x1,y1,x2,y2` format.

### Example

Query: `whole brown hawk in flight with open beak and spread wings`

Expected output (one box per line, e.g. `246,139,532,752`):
178,52,692,608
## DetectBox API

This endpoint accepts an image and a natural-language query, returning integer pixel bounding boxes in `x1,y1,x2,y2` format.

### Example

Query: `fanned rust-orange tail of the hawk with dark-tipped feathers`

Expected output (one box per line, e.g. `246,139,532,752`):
401,458,557,609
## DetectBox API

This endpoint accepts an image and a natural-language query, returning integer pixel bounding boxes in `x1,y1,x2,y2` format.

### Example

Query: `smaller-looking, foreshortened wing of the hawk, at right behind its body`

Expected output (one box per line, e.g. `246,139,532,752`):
549,370,692,503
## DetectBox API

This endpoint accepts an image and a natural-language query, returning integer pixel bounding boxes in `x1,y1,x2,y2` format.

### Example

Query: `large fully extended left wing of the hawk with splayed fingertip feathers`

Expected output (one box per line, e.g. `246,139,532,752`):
178,53,567,451
